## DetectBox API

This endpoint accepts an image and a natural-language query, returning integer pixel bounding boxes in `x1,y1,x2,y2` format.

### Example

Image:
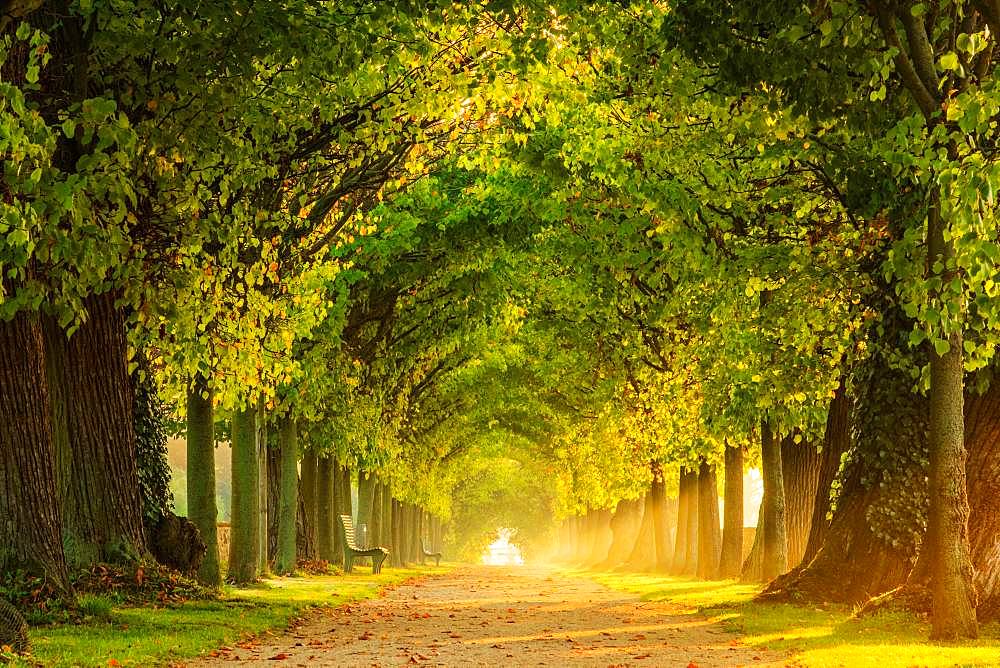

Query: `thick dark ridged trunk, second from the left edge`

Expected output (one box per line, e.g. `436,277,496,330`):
46,292,146,568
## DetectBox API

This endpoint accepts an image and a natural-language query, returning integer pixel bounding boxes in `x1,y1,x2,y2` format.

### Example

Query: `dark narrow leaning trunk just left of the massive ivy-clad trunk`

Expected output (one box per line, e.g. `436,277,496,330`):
800,381,853,565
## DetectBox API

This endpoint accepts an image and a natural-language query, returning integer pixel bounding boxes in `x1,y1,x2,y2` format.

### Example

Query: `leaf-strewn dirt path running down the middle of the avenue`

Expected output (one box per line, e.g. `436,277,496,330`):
198,566,783,668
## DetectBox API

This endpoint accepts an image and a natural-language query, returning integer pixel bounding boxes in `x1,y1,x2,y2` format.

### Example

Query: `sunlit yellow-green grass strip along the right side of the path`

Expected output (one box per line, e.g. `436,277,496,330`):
568,571,1000,668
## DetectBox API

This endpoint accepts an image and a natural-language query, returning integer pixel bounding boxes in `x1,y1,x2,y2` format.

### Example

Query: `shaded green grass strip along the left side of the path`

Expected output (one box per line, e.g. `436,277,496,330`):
24,566,448,666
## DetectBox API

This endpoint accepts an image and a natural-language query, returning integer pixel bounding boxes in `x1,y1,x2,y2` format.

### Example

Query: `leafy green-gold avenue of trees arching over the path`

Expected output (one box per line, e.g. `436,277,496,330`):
0,0,1000,639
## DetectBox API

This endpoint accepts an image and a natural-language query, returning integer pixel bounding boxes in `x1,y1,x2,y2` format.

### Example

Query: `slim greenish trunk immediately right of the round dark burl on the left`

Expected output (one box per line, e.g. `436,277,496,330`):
187,376,222,587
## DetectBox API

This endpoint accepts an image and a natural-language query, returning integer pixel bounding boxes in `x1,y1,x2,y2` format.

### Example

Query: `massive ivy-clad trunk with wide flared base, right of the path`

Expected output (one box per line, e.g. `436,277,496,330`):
758,358,928,605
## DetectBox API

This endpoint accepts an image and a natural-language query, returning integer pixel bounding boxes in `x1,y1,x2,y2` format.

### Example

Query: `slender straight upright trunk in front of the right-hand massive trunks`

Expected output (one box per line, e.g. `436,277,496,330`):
927,202,979,640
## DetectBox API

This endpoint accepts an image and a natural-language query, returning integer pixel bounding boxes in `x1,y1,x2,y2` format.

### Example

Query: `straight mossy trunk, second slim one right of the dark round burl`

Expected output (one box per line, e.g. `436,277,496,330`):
228,406,260,584
